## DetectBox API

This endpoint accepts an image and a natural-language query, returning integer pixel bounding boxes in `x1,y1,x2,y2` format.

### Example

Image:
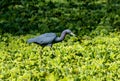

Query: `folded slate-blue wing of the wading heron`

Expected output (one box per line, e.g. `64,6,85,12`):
34,33,56,45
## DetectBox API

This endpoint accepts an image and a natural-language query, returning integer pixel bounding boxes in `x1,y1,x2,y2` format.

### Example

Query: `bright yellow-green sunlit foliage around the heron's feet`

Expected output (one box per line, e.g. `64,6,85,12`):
0,33,120,81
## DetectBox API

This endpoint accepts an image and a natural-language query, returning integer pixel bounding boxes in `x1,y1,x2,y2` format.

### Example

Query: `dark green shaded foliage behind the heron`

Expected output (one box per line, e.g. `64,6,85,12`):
0,0,120,36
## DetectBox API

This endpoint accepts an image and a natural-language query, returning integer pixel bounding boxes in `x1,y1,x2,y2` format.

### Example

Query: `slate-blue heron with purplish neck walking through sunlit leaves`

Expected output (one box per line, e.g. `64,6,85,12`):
27,29,75,47
